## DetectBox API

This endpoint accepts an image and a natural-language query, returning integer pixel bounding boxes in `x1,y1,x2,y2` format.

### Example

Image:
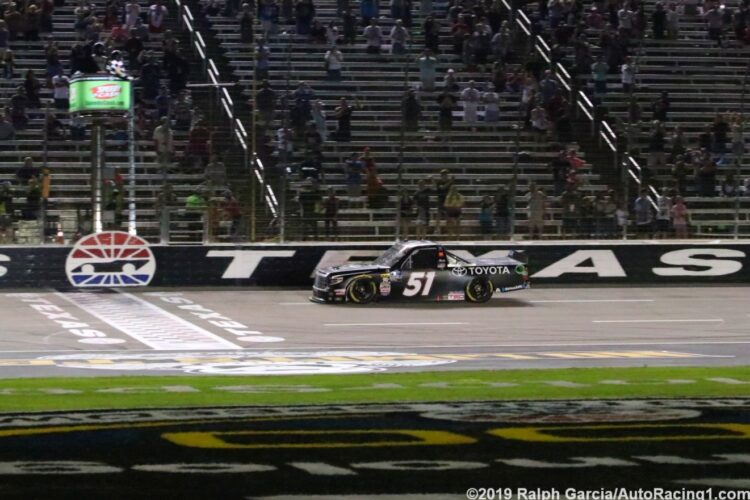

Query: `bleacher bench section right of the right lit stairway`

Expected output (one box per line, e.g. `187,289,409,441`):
567,0,750,236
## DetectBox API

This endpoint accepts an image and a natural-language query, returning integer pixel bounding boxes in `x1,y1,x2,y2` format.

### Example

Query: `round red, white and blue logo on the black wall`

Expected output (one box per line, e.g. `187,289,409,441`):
65,231,156,287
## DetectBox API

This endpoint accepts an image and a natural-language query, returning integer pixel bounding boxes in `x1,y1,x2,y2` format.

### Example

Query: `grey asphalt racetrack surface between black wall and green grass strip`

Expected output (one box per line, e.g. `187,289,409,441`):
0,286,750,378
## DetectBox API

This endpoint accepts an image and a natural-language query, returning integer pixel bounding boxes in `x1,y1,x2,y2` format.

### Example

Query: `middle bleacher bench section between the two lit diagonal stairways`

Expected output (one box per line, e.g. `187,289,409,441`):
189,0,606,240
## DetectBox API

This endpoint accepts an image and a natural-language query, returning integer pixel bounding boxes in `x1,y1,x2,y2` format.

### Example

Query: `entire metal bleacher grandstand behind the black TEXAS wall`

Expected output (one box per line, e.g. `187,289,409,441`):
0,0,750,242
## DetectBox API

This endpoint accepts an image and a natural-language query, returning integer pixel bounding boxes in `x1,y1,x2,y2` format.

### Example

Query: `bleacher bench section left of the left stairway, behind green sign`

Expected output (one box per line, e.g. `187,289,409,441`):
0,0,217,242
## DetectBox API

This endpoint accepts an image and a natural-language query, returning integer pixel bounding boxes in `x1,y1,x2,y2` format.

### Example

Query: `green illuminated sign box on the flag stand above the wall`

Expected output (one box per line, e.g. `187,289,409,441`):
69,77,130,113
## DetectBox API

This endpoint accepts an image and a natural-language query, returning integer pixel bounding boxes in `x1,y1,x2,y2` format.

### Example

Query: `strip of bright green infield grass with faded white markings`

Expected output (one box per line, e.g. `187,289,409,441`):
0,367,750,412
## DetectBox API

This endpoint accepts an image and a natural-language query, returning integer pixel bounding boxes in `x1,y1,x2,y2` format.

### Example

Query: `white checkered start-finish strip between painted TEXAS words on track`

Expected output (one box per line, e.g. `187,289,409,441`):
55,292,242,351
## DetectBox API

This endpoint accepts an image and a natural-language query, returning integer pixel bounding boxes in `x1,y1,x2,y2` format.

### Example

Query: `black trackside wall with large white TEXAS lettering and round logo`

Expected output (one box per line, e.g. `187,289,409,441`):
0,232,750,288
